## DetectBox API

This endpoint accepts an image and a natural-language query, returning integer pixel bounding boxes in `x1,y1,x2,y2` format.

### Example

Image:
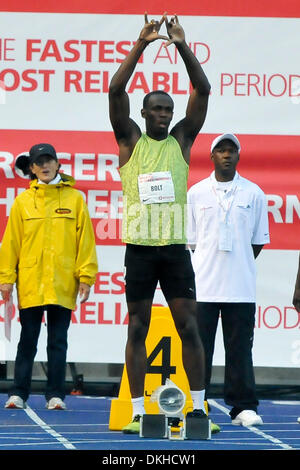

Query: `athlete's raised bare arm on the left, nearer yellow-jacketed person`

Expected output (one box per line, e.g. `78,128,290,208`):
109,13,168,166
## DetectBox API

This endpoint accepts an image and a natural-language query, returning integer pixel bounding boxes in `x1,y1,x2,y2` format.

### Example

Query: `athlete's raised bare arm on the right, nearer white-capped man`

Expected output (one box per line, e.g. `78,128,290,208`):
165,15,210,162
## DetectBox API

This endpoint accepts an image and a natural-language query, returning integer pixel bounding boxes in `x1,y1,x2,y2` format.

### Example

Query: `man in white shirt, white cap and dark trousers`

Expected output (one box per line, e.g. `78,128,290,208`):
188,134,270,426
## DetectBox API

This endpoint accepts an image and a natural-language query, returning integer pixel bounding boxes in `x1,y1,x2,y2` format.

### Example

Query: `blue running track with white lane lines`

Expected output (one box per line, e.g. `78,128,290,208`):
0,394,300,460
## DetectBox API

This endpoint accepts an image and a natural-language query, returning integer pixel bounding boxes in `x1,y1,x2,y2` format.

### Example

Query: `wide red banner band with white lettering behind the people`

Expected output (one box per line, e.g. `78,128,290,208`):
0,130,300,250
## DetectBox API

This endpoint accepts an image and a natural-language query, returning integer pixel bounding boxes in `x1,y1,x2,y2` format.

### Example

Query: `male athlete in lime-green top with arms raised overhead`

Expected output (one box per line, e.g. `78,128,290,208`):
109,14,214,433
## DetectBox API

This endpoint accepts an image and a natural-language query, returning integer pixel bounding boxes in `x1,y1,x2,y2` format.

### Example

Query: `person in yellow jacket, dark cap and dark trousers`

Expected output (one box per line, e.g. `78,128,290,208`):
0,144,98,409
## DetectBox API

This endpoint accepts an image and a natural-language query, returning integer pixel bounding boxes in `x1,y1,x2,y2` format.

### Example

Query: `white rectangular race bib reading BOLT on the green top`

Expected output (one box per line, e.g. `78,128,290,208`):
138,171,175,204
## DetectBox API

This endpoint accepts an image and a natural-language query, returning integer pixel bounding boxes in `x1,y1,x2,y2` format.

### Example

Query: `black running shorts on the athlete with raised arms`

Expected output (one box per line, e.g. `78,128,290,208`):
125,244,196,302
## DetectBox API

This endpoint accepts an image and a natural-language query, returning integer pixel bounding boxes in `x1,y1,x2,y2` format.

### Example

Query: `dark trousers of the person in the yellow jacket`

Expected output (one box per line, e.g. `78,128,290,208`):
10,305,71,401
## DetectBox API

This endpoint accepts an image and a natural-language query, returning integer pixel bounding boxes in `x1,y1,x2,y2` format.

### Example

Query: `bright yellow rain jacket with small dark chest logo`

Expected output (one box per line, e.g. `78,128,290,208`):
0,174,98,310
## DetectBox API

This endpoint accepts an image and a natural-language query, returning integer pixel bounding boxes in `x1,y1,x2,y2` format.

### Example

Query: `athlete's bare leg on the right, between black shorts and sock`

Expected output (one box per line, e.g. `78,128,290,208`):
168,298,205,390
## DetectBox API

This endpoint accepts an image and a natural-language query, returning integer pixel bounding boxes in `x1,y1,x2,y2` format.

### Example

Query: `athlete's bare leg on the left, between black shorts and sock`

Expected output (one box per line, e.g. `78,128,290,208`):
125,298,152,398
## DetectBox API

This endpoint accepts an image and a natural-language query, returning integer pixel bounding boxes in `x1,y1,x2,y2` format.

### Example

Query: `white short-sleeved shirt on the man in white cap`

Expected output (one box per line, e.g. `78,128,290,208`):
187,172,270,302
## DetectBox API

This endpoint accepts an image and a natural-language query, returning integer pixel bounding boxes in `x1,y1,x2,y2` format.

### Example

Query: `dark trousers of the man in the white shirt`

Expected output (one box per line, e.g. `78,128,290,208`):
197,302,258,419
